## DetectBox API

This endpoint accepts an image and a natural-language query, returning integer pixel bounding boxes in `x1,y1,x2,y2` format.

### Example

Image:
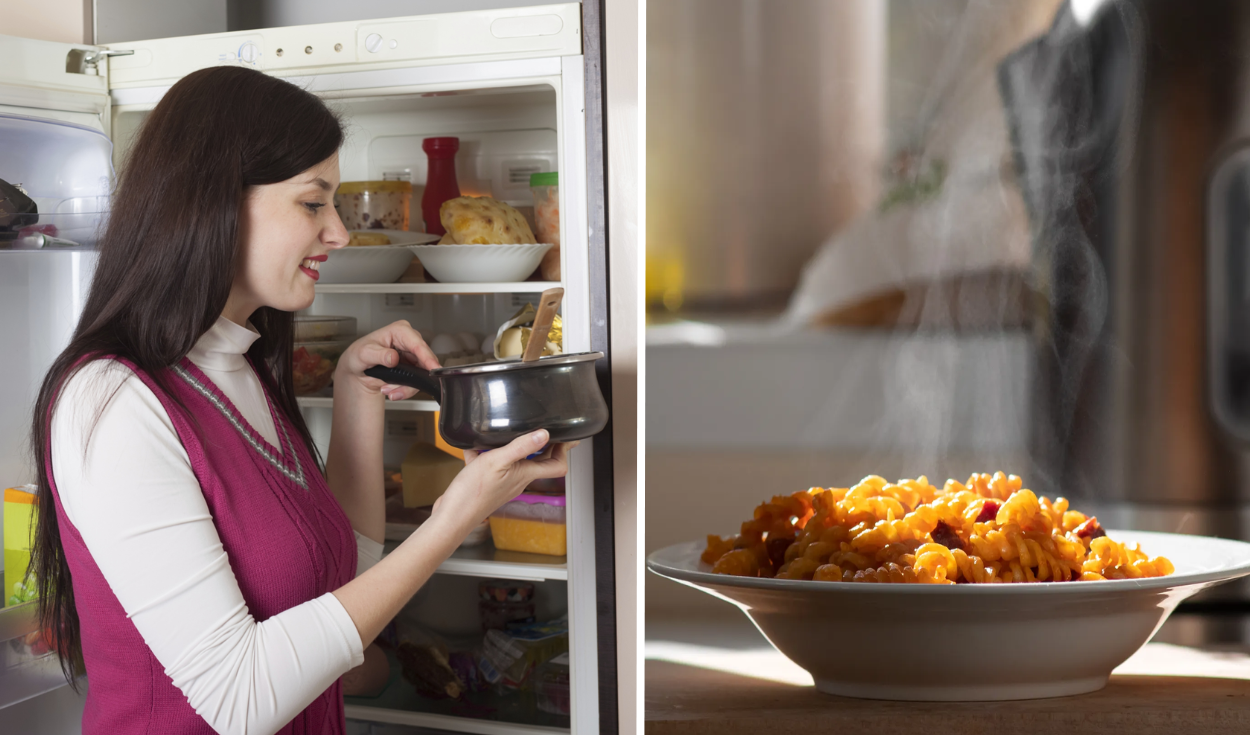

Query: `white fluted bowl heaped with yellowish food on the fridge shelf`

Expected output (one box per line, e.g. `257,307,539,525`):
411,196,554,284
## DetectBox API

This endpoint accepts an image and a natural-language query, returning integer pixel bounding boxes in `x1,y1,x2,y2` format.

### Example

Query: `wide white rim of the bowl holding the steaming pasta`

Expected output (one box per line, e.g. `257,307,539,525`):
646,529,1250,596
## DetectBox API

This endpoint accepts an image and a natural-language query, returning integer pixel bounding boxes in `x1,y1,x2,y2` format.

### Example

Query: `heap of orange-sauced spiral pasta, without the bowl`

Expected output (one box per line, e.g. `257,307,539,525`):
703,473,1174,584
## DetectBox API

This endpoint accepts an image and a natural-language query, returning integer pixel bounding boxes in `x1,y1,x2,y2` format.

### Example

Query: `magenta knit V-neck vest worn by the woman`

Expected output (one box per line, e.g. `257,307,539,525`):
46,359,356,735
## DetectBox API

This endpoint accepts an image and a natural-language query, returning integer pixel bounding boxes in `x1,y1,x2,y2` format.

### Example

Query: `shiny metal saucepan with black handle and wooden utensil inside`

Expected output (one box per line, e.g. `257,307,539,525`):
365,289,608,450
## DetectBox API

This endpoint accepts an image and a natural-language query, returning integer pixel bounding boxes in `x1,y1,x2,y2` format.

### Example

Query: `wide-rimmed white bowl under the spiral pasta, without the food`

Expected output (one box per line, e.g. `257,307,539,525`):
646,530,1250,701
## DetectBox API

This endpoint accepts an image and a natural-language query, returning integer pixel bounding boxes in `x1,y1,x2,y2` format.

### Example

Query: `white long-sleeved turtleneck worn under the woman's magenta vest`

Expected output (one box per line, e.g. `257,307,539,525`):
51,318,383,735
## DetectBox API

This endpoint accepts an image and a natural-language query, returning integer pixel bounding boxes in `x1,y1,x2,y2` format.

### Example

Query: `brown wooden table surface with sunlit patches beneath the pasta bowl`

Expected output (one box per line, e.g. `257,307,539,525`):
645,629,1250,735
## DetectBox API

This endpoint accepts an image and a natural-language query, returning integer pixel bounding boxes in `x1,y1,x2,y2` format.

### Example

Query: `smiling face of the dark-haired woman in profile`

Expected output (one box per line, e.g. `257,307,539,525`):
224,154,348,324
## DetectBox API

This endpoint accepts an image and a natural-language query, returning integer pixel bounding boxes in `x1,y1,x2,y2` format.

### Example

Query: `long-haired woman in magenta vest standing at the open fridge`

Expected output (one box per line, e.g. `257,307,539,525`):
33,68,569,735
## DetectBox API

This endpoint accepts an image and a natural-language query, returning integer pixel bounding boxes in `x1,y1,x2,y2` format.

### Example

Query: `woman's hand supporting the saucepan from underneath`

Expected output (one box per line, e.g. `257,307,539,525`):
430,429,579,538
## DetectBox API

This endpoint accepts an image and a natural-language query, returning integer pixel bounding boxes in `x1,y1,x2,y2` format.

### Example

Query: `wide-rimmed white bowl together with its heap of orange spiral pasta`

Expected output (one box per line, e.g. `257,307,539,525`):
646,473,1250,701
